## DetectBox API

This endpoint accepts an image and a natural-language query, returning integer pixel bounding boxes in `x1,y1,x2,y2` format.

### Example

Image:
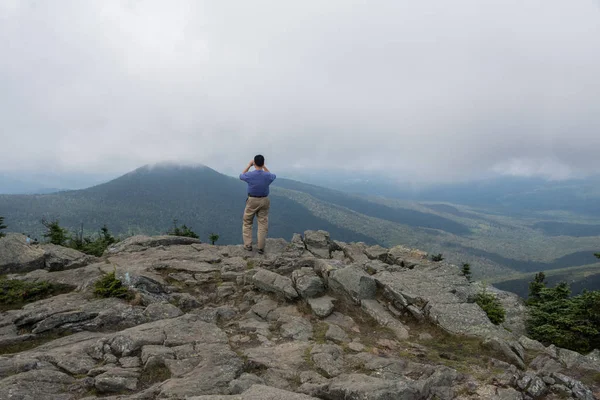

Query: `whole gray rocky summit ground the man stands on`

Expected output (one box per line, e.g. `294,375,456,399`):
0,231,600,400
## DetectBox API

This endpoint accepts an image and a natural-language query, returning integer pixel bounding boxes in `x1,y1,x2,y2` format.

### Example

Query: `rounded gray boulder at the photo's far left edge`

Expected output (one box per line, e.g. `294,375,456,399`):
0,233,46,274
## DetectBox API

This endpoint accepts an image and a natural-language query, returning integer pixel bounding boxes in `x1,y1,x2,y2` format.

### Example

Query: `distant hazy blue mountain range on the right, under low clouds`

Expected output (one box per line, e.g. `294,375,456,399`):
295,172,600,219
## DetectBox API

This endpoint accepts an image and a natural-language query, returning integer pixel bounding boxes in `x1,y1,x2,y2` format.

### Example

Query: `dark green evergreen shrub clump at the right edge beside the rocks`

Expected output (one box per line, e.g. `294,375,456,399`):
527,273,600,352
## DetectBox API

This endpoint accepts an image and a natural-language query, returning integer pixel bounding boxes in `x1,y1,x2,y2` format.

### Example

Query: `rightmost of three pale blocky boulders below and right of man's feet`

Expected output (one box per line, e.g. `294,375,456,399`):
329,266,377,304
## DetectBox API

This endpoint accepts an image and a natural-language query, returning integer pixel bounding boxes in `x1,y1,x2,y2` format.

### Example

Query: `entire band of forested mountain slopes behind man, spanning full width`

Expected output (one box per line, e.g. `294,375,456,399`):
0,164,600,289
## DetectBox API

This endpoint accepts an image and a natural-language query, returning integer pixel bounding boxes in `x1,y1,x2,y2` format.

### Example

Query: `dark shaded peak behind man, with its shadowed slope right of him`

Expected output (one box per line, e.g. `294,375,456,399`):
0,164,376,244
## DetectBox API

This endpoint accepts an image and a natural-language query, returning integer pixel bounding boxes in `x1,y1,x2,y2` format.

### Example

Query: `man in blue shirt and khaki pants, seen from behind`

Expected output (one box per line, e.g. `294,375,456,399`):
240,154,276,254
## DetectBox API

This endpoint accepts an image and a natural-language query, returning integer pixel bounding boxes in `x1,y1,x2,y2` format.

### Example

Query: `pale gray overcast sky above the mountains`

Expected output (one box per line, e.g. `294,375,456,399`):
0,0,600,181
